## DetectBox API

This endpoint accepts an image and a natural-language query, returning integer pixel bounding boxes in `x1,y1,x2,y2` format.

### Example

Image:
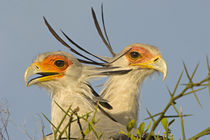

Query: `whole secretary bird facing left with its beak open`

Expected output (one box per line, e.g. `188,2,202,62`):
24,51,133,139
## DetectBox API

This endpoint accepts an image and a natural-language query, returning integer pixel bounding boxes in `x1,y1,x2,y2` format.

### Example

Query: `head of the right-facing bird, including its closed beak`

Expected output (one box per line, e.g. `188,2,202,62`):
114,43,167,80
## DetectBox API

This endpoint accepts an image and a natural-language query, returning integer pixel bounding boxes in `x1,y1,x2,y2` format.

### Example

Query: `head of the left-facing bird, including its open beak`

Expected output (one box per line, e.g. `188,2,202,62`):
24,51,82,88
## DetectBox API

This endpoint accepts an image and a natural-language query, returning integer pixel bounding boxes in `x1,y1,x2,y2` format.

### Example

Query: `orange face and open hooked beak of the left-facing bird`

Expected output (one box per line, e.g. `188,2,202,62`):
24,54,73,86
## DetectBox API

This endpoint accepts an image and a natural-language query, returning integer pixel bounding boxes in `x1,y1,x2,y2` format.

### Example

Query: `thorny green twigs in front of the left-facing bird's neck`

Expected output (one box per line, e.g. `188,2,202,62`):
42,102,102,140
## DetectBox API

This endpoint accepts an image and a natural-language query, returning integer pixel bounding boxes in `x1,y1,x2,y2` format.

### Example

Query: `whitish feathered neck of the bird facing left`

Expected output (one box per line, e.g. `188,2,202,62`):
42,66,95,133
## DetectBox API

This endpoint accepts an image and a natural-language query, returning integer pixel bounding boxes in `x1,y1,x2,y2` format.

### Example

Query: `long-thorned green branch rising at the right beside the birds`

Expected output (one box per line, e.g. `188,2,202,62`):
122,57,210,140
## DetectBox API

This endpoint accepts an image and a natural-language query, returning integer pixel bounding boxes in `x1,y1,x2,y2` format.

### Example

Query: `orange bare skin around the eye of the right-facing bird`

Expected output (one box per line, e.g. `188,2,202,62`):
126,46,154,64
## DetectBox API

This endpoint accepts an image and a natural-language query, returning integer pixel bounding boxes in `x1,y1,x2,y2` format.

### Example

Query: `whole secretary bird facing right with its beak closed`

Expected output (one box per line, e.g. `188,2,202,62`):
102,43,167,125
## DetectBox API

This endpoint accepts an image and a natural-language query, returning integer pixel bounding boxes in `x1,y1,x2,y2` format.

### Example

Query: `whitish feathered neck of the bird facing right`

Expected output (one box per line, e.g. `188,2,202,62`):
102,70,153,125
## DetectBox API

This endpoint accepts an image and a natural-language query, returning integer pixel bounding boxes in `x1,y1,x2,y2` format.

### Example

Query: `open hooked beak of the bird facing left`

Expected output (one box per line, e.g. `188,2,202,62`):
24,62,63,87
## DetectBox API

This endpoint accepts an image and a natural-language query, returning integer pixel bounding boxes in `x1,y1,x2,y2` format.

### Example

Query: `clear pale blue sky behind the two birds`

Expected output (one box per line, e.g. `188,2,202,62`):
0,0,210,139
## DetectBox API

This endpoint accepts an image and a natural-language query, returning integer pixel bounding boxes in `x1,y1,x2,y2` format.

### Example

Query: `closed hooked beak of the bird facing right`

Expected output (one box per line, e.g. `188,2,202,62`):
131,56,167,81
